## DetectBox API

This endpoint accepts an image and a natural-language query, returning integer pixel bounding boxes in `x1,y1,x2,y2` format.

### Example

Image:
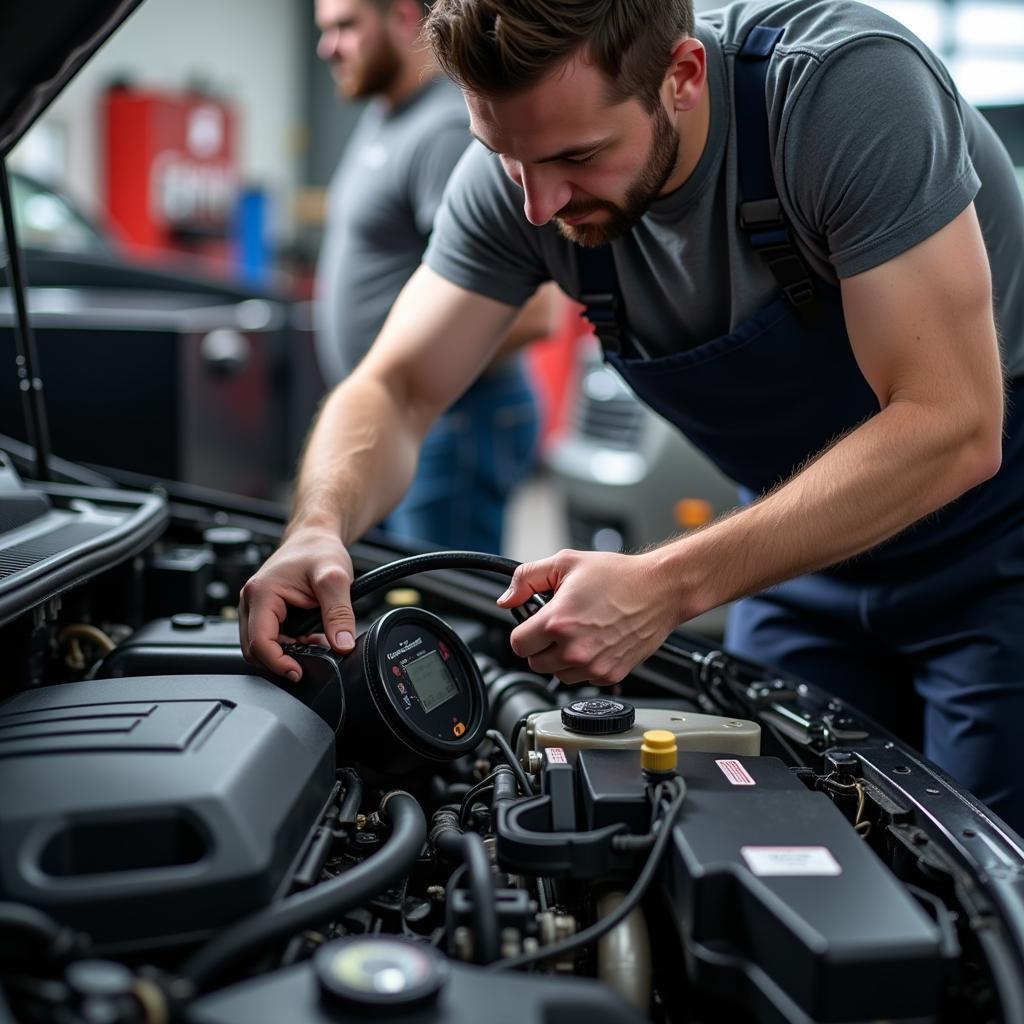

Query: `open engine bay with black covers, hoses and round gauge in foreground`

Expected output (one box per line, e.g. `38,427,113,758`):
0,469,1024,1024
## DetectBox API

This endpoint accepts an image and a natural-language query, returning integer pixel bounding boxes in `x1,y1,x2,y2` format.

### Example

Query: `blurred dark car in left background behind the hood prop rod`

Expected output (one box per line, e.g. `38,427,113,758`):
0,173,324,499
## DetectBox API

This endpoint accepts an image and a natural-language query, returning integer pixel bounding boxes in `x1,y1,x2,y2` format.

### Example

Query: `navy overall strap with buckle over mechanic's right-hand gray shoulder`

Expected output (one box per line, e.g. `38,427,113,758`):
733,25,821,326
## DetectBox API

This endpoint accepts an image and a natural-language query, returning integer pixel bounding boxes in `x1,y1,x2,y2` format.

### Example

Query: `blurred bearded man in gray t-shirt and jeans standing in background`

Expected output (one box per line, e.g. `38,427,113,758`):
314,0,557,553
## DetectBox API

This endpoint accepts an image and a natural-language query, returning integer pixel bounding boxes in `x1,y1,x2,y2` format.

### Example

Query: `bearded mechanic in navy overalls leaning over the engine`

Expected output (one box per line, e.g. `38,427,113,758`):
241,0,1024,829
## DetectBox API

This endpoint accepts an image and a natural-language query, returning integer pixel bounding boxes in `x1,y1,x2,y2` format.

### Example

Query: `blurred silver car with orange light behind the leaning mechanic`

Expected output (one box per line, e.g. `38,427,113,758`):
548,341,736,637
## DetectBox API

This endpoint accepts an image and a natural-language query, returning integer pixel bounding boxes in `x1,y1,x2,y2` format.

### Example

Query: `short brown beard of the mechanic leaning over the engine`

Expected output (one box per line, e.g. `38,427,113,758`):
554,103,679,247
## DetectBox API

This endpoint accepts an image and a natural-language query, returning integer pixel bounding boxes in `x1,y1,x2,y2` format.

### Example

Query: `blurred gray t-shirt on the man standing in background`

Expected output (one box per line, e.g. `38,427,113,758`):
314,77,468,385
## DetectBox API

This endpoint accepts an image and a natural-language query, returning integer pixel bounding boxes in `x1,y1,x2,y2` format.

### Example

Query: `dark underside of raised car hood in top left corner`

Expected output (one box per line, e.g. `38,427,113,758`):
0,0,142,158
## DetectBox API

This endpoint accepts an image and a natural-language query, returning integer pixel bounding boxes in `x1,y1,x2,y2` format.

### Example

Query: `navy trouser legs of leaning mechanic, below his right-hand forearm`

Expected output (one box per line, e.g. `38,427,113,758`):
726,524,1024,835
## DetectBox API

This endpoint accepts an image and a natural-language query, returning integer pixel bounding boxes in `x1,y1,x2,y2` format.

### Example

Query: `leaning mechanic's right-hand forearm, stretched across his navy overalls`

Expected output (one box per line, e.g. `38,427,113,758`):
651,401,998,622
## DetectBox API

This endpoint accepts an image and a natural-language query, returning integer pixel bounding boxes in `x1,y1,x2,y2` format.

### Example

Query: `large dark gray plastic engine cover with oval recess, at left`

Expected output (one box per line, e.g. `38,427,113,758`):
0,676,335,952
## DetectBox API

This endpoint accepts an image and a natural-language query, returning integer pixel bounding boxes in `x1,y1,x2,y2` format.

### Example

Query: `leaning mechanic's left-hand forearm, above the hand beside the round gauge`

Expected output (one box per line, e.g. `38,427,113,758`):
286,372,420,545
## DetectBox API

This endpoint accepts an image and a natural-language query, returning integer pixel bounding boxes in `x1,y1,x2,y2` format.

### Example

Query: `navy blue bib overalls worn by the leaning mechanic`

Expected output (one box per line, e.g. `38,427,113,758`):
579,27,1024,833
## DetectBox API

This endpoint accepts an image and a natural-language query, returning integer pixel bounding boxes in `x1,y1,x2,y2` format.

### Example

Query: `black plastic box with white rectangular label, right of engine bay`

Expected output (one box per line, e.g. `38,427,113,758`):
666,753,944,1021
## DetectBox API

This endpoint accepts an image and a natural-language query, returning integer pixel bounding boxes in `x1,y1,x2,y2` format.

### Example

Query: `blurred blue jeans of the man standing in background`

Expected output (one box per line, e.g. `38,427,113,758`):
382,359,540,554
